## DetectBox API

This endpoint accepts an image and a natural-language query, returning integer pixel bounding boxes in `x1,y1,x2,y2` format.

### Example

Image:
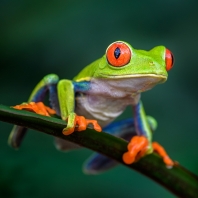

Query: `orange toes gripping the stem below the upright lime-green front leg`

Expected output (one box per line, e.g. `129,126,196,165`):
63,115,102,135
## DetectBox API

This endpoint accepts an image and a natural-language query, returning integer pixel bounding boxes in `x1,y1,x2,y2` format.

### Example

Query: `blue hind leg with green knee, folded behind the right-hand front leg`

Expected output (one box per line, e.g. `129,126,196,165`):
83,116,157,174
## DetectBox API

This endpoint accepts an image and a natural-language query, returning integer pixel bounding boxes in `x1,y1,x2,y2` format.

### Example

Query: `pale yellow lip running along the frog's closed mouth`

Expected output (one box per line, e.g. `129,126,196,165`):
100,74,167,83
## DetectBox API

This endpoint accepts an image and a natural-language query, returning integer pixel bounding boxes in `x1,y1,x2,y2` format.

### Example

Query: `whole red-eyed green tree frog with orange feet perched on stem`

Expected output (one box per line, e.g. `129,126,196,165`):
9,41,174,173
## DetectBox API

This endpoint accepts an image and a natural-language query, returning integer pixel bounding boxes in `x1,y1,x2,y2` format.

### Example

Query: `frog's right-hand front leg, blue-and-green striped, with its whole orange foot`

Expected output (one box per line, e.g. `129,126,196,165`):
123,102,174,167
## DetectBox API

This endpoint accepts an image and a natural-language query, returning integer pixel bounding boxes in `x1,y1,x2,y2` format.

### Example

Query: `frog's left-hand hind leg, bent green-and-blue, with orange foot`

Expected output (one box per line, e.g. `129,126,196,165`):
8,74,60,148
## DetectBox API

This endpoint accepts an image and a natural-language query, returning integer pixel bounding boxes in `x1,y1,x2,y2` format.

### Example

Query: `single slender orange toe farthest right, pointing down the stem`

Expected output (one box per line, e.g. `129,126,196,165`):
152,142,174,168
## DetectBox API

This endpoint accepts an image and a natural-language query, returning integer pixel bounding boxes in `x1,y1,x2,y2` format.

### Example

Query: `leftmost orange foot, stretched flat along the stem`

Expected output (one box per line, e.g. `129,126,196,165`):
13,102,56,116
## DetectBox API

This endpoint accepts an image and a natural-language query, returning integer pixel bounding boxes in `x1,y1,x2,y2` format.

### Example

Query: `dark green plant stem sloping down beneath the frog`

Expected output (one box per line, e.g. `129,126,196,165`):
0,105,198,198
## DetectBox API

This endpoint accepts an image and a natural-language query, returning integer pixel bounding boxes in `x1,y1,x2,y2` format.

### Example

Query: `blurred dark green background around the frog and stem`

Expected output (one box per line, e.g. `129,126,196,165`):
0,0,198,198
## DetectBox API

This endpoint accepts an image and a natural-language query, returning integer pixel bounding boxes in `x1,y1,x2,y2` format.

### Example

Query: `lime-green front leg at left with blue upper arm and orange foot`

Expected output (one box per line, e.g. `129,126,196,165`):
57,80,102,135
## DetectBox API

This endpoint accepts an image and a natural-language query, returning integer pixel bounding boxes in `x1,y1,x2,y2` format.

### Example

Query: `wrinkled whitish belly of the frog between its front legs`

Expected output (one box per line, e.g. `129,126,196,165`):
75,77,140,127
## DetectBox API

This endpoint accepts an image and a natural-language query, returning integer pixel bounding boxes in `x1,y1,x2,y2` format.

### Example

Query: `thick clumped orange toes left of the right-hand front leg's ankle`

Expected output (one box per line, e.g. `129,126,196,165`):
122,136,149,164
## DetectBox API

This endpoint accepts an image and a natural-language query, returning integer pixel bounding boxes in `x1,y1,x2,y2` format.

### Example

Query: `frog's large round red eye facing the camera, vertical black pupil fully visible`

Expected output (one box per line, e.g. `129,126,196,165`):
106,42,131,67
